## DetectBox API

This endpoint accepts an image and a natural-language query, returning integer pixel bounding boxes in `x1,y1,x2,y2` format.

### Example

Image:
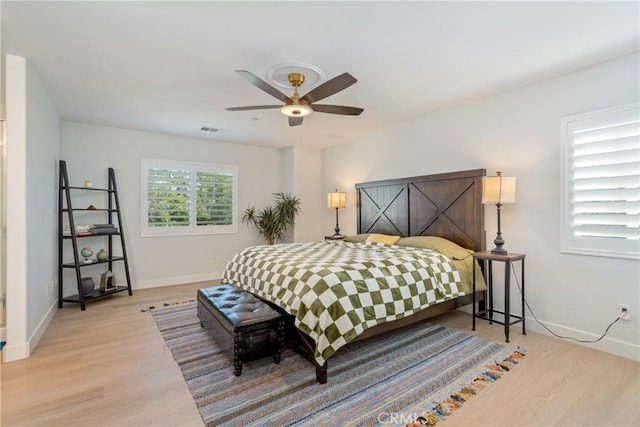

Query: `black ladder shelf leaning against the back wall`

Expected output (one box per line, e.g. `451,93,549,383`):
58,160,133,310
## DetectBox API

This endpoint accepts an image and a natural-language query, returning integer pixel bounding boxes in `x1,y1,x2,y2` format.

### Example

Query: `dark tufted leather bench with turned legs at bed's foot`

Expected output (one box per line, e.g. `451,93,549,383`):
198,285,285,376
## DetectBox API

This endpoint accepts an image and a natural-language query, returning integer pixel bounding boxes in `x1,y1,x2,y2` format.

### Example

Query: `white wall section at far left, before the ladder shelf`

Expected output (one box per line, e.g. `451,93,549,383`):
4,55,61,361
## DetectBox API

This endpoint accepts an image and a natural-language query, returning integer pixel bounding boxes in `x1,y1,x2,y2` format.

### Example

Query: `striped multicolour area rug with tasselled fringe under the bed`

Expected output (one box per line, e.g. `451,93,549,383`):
151,302,524,426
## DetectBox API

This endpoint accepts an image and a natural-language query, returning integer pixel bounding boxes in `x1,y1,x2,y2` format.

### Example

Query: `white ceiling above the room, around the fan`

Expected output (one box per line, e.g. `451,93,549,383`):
0,1,640,147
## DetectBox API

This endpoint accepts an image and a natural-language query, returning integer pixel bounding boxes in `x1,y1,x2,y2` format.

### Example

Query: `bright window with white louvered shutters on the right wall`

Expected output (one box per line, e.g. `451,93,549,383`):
561,104,640,259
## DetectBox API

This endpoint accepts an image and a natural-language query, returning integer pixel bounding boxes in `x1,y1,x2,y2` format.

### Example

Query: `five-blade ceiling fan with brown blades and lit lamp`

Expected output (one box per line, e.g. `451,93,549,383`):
226,70,364,126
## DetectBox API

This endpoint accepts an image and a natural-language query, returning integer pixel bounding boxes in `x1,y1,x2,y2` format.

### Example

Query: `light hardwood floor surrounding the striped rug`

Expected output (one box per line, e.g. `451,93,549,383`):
0,283,640,427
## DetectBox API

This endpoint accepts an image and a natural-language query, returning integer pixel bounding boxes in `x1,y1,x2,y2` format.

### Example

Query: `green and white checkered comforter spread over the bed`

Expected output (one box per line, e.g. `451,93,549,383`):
222,241,464,365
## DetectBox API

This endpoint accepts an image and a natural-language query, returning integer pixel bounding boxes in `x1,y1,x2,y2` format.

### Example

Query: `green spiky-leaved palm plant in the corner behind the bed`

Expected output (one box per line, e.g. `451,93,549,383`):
242,192,300,245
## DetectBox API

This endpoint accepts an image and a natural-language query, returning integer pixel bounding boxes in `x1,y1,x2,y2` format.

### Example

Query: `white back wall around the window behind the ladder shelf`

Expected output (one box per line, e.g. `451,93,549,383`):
62,122,282,293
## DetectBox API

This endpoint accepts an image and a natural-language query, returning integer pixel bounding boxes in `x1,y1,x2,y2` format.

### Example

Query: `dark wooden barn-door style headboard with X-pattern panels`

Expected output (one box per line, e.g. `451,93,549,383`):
356,169,486,251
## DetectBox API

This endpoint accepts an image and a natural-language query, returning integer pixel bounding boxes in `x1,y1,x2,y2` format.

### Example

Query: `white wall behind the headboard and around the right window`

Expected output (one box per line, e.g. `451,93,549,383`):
322,54,640,360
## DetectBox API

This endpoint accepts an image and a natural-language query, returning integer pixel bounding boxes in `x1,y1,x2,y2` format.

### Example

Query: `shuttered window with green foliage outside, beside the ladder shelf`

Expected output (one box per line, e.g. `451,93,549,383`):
142,159,238,236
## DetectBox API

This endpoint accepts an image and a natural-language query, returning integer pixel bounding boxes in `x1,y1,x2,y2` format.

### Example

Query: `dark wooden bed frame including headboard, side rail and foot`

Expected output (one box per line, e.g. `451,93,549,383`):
289,169,486,383
